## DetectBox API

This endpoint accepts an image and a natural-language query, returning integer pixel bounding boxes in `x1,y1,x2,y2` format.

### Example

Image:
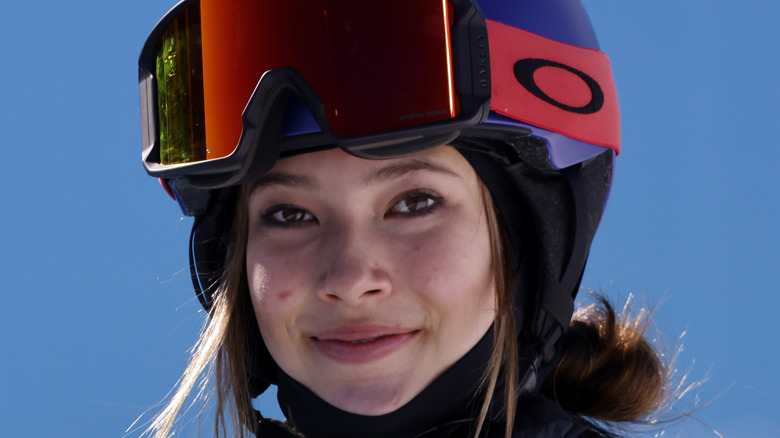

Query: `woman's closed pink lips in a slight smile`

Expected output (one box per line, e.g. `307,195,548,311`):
310,327,418,365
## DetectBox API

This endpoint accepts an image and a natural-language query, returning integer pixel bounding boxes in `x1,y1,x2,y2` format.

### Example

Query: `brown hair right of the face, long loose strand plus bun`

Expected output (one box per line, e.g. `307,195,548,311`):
474,184,670,438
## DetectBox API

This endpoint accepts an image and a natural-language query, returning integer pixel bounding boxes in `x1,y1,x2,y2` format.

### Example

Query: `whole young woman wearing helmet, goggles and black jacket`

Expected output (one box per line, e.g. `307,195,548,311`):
139,0,666,438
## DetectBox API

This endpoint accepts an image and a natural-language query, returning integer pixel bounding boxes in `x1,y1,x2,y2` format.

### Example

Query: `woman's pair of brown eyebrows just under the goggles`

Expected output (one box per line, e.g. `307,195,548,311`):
249,159,460,193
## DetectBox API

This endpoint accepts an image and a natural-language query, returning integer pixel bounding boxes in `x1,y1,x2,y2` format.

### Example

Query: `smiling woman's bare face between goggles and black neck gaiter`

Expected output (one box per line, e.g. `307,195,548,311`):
246,146,496,415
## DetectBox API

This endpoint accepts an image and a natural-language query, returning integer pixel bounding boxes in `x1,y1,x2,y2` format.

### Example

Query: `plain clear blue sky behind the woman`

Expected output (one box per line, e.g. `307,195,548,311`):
0,0,780,438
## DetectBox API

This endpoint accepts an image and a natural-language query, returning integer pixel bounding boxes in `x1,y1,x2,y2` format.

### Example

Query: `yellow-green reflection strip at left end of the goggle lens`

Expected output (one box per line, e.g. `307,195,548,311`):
155,2,206,164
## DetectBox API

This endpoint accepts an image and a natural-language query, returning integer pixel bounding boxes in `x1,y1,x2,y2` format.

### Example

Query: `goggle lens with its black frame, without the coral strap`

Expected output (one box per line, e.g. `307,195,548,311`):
139,0,490,188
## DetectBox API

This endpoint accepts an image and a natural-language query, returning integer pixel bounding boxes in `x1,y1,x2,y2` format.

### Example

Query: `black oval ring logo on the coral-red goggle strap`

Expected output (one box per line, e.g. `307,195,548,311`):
514,58,604,114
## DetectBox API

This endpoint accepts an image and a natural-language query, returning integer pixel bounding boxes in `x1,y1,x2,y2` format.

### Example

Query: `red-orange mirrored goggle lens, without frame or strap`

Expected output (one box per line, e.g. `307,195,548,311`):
149,0,460,164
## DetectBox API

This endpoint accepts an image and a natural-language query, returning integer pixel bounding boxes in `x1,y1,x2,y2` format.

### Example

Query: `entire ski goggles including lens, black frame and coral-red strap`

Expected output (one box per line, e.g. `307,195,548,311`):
139,0,619,189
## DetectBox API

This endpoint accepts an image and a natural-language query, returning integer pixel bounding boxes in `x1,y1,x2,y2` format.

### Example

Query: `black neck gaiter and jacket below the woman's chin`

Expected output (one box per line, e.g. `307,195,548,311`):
255,330,603,438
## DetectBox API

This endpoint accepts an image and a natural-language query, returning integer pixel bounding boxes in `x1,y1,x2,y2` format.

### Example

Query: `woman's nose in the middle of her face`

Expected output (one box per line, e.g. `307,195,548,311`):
317,222,392,305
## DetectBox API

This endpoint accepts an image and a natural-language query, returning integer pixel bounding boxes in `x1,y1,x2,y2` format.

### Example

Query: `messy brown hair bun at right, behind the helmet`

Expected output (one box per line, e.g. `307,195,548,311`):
542,297,668,430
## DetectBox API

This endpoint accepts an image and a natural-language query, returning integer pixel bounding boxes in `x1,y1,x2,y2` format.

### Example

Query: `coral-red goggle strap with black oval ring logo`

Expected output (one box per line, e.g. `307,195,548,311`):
487,20,620,152
